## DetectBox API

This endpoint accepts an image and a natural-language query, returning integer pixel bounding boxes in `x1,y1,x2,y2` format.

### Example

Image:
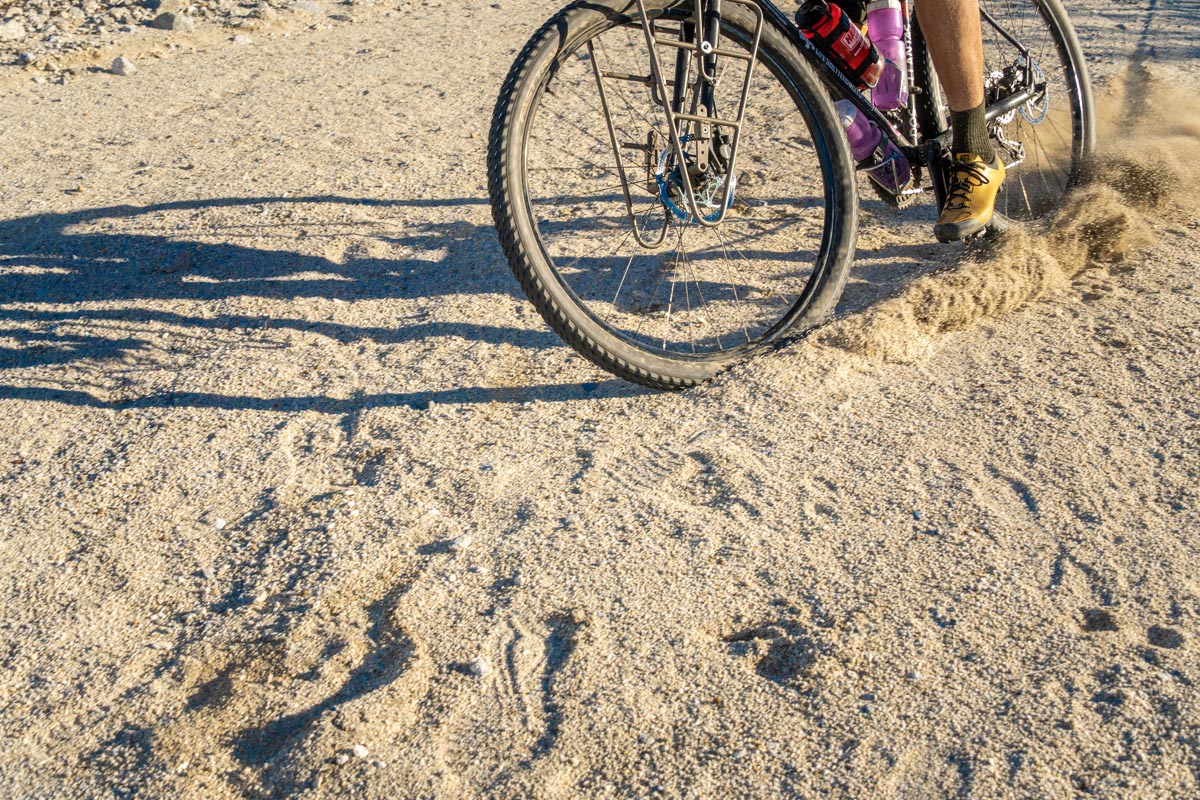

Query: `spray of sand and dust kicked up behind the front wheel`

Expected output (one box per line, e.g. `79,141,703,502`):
818,73,1200,362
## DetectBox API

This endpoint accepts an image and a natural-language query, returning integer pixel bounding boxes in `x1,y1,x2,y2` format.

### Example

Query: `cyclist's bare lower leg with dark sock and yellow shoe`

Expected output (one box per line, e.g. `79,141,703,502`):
916,0,1004,241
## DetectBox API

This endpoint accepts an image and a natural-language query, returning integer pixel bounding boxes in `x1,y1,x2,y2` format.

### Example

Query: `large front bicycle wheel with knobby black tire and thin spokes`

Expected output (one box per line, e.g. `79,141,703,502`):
488,0,857,389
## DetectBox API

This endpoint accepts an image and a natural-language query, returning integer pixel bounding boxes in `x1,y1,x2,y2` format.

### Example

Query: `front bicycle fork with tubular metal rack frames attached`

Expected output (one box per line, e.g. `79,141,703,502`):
588,0,763,249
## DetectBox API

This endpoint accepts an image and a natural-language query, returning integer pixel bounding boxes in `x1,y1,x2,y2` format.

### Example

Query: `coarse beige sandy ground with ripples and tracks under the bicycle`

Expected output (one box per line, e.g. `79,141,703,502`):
0,0,1200,799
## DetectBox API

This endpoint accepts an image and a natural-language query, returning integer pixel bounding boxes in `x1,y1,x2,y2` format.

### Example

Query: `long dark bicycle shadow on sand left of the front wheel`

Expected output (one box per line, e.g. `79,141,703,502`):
0,196,657,413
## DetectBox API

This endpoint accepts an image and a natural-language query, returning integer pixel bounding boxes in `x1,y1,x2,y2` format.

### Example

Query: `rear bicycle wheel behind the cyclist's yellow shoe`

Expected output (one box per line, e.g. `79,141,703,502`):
979,0,1096,222
